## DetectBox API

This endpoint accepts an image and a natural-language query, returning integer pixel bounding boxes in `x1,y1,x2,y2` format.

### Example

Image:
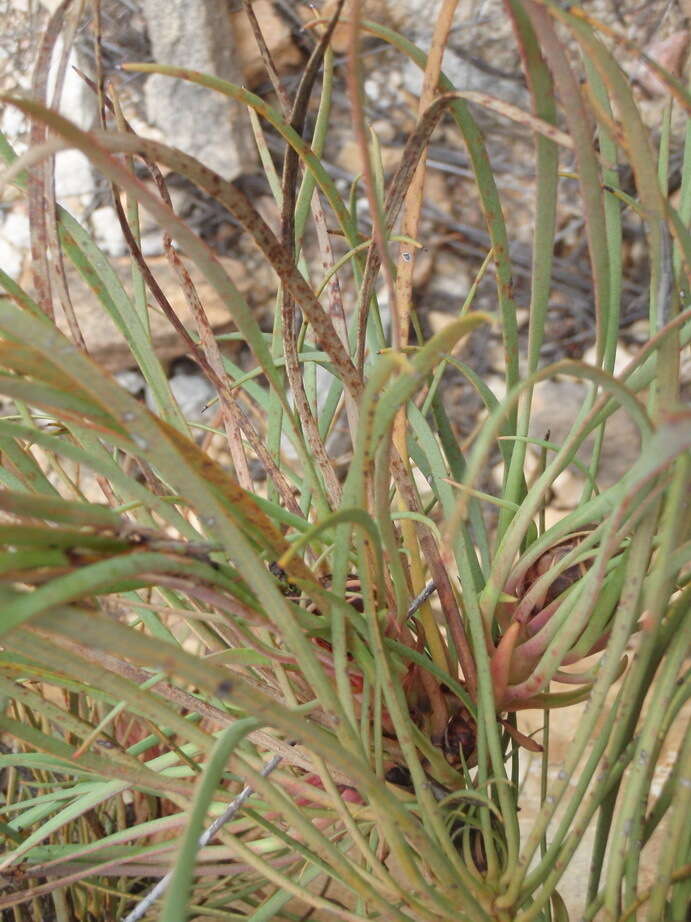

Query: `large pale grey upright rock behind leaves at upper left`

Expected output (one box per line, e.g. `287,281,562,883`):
142,0,256,179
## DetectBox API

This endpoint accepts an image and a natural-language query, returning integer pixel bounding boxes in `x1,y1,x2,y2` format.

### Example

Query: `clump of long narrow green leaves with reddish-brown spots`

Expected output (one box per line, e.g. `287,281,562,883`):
0,0,691,922
